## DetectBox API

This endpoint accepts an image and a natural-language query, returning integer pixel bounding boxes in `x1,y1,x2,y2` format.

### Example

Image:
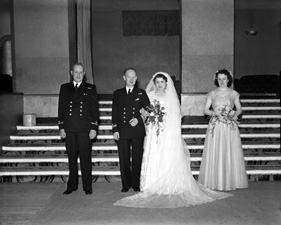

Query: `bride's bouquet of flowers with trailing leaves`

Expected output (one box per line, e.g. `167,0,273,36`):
145,100,165,136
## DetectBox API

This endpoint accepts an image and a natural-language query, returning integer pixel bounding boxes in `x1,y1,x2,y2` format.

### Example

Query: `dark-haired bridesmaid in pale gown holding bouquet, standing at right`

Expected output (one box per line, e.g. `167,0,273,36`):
198,69,248,191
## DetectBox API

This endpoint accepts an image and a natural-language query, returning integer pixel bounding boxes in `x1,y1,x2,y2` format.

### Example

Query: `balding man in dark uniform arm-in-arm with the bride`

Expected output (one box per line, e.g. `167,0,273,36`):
112,68,150,192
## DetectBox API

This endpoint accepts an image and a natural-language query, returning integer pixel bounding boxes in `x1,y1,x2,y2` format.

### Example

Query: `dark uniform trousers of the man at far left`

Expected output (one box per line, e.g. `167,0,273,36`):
65,132,92,191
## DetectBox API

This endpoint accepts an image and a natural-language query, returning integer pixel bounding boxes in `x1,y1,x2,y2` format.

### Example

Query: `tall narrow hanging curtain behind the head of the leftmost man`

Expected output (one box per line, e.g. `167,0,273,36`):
76,0,94,83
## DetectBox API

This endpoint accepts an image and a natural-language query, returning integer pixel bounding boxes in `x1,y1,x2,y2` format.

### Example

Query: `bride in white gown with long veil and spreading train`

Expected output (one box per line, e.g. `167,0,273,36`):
114,72,231,208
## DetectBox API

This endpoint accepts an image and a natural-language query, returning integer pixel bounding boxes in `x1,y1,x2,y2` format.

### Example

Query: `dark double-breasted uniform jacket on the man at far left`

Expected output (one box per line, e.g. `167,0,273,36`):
58,82,99,132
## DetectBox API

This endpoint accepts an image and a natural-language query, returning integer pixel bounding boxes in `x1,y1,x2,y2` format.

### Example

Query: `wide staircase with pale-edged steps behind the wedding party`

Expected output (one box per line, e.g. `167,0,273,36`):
0,95,281,183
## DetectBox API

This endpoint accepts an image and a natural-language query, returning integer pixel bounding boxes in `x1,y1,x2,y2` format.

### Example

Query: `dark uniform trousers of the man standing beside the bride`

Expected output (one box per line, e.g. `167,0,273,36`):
117,137,144,189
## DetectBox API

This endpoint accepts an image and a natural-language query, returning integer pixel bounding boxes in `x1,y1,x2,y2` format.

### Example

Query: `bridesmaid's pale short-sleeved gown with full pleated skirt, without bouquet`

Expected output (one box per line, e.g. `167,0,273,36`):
198,90,248,191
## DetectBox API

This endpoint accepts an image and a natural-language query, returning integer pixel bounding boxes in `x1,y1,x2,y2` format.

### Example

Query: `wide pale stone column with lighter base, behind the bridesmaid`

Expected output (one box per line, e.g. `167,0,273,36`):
181,0,234,116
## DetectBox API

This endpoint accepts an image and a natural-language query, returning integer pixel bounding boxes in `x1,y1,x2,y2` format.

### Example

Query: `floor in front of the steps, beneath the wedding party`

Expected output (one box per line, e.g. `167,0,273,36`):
0,181,281,225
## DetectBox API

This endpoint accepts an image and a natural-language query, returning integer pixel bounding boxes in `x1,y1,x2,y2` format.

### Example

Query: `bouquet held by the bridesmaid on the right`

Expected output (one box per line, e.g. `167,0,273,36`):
210,104,239,134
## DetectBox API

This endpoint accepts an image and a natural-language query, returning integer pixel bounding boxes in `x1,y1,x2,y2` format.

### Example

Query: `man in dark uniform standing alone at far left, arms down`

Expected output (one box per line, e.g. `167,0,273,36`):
58,63,99,195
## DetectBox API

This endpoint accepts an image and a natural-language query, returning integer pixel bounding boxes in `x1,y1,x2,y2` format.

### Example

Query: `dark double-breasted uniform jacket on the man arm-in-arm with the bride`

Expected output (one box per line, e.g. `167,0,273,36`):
112,87,150,139
